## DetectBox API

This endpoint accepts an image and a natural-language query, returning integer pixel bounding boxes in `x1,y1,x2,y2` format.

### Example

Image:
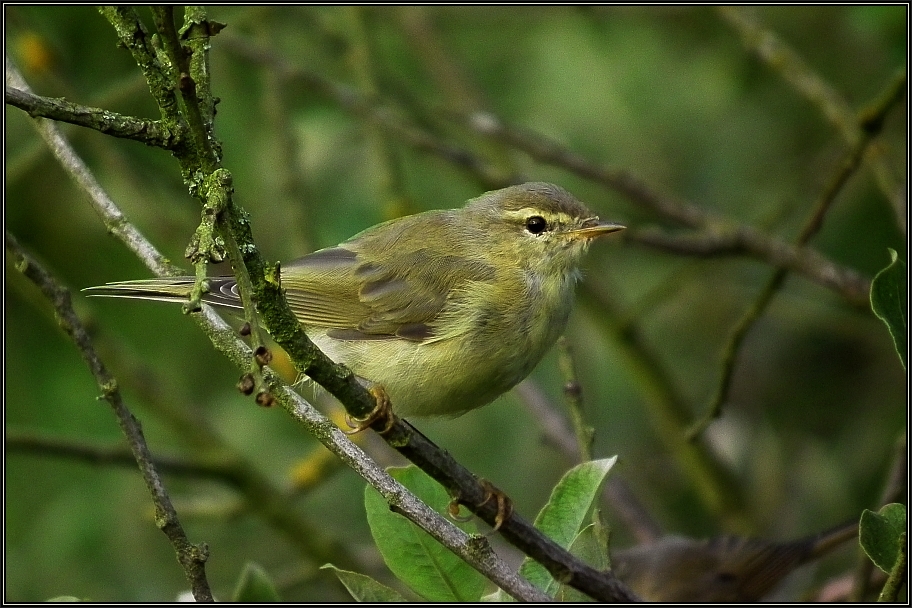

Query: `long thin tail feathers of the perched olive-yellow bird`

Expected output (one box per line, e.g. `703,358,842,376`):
82,277,241,308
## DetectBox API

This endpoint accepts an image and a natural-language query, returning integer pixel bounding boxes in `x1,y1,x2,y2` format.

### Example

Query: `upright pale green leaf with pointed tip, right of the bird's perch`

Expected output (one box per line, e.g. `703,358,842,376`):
519,456,617,597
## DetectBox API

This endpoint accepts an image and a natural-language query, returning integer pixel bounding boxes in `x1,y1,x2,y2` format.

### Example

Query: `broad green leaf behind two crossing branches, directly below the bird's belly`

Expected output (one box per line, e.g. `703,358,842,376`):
364,466,486,602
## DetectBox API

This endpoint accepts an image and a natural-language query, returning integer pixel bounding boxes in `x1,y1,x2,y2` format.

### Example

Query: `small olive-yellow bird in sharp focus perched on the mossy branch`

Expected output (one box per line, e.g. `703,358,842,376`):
89,182,624,416
